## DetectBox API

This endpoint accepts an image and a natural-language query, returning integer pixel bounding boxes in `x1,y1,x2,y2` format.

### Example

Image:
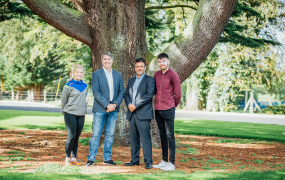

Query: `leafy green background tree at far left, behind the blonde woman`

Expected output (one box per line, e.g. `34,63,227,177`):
0,17,92,100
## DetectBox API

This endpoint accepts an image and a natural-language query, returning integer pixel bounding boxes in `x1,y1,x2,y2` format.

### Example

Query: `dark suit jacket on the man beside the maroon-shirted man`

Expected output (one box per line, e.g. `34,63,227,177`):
124,75,155,120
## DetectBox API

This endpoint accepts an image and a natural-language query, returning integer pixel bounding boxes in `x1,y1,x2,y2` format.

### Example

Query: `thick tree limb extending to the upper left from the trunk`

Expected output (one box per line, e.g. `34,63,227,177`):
22,0,92,46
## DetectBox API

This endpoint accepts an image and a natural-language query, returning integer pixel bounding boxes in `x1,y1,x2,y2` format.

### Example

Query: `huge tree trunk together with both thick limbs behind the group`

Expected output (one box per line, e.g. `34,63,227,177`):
23,0,237,144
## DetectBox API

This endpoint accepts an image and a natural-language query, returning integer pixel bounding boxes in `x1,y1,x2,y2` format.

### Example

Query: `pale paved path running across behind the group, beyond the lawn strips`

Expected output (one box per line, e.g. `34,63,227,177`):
0,101,285,125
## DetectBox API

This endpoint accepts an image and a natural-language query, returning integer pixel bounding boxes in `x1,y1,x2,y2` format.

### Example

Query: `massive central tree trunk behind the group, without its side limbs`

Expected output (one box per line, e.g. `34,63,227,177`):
85,0,159,146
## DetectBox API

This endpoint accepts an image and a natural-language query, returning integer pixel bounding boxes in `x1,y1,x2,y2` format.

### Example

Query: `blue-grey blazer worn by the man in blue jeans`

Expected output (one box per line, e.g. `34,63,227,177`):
91,68,124,112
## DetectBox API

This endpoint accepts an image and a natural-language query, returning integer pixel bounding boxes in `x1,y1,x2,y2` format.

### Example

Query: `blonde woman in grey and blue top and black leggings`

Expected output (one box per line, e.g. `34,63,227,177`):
61,64,88,166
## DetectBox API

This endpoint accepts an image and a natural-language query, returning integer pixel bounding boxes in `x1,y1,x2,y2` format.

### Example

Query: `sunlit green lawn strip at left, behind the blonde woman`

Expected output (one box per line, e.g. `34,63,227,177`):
0,110,93,132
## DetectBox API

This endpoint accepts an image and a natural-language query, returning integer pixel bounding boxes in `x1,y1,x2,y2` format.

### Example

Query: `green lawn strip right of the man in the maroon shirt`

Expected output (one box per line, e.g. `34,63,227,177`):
174,119,285,142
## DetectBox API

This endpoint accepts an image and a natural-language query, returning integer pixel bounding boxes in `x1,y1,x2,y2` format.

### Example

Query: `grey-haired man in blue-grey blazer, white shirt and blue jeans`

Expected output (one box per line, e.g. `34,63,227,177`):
86,52,124,166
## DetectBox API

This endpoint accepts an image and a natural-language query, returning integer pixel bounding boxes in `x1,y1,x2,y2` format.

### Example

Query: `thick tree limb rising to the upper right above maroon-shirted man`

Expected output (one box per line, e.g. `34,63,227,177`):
148,0,238,82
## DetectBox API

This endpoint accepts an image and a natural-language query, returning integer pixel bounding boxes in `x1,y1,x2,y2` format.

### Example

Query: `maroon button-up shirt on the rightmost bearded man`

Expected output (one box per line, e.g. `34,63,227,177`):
154,68,181,110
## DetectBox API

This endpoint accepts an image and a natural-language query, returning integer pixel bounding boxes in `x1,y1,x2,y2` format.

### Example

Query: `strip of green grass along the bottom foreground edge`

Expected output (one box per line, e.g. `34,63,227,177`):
0,170,285,180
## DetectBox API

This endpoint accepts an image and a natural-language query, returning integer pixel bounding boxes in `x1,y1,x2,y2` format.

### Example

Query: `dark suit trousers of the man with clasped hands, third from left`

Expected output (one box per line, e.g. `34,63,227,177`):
129,112,153,164
